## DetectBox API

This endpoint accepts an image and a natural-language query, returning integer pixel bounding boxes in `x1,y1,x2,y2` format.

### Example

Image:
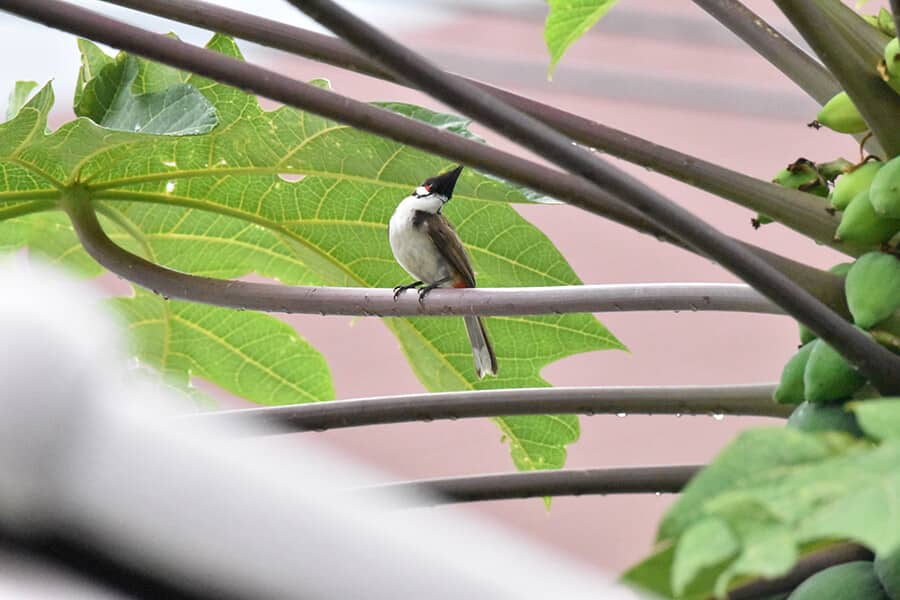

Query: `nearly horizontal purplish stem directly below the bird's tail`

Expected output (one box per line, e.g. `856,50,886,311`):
188,383,795,435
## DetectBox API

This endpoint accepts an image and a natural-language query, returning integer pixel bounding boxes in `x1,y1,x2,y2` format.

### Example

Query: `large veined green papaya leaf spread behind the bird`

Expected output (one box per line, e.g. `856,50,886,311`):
0,35,623,469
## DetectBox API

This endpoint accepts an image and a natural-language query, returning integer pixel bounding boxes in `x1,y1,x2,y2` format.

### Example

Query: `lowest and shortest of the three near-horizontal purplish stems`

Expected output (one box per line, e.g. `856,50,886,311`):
346,465,704,508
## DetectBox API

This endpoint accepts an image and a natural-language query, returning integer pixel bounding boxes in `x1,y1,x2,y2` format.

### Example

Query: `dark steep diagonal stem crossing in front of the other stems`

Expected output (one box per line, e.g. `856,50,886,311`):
290,0,900,394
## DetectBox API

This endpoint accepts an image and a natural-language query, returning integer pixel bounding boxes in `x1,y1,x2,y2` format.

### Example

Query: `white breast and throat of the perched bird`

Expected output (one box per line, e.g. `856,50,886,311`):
388,195,450,284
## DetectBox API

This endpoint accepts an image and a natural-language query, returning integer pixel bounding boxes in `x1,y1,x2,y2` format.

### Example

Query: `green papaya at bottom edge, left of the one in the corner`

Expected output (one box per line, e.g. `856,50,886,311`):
788,560,891,600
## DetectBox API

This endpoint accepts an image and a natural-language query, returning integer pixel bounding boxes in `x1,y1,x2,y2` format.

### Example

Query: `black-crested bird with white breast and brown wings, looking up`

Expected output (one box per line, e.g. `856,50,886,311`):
388,166,497,379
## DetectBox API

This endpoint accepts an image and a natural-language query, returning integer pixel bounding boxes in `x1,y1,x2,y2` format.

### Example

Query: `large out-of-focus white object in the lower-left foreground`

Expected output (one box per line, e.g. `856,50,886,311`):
0,263,638,600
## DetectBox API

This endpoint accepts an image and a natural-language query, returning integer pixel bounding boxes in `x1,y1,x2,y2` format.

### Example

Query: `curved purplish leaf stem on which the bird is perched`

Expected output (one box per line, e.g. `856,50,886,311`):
63,197,783,317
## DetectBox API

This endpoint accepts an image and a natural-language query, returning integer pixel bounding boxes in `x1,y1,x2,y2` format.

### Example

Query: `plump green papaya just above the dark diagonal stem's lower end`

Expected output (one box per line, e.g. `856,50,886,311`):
844,252,900,329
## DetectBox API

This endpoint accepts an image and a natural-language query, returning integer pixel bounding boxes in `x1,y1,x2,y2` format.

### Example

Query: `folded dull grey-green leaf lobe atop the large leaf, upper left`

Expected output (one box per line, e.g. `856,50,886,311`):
75,55,218,135
